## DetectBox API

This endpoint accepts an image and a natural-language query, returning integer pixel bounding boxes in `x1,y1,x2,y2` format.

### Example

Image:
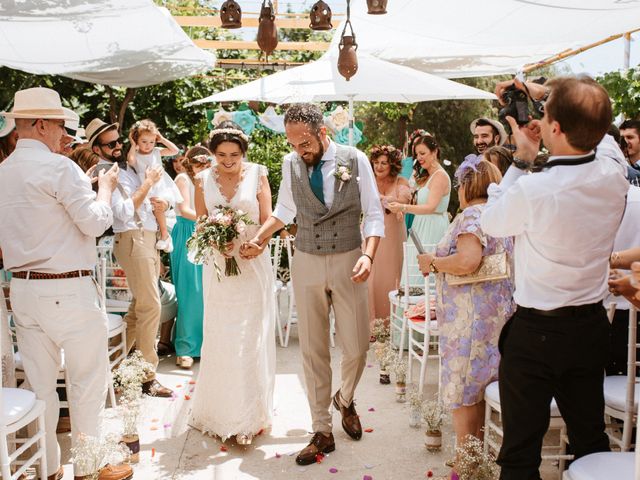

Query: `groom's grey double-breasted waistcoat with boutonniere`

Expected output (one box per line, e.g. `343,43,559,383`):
291,144,362,255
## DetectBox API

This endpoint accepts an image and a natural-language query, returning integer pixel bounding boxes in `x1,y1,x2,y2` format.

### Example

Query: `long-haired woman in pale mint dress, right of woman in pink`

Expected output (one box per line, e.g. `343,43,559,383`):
388,134,451,266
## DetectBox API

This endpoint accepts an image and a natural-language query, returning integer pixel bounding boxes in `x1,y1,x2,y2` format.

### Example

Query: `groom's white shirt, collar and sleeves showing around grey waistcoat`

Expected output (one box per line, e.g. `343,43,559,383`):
273,140,384,238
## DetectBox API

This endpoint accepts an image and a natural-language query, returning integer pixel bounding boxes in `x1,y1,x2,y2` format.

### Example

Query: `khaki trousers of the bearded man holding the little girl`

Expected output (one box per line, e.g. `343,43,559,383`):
113,230,161,380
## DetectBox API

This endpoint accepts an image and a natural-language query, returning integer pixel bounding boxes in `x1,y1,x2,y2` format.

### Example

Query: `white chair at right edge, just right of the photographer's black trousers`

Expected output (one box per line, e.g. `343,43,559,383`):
604,304,640,452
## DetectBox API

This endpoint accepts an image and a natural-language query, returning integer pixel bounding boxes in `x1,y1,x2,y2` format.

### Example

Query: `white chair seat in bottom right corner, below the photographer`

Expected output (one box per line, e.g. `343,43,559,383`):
562,400,640,480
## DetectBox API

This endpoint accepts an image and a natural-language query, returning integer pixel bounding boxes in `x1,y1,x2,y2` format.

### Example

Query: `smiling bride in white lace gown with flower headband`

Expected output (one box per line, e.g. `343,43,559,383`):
190,122,276,445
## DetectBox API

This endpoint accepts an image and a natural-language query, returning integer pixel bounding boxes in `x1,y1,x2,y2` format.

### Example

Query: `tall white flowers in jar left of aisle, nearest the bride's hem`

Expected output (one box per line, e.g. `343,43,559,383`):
113,350,153,463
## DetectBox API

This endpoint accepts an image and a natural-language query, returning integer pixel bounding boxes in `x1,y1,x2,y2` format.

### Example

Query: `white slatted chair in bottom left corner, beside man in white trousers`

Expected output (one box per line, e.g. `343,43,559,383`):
0,348,47,480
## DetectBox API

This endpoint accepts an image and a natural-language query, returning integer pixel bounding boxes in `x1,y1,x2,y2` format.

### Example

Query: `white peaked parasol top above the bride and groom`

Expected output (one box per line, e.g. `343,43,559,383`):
185,53,495,105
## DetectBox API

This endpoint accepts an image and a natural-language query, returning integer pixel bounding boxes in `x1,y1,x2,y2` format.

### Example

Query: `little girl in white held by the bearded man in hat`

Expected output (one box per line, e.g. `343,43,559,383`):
127,119,183,253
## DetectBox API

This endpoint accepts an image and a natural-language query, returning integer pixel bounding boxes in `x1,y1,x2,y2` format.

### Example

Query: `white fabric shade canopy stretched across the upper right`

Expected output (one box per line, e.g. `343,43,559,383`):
332,0,640,78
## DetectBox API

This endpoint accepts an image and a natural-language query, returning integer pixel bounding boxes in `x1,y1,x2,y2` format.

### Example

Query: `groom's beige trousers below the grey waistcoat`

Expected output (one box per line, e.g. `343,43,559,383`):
291,249,369,433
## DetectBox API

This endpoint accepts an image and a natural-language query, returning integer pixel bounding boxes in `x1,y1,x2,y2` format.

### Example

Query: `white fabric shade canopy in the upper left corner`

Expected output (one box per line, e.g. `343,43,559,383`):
0,0,215,87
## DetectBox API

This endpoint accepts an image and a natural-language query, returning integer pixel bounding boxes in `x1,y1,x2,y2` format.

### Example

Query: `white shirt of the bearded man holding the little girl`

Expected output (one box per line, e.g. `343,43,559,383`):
98,159,158,233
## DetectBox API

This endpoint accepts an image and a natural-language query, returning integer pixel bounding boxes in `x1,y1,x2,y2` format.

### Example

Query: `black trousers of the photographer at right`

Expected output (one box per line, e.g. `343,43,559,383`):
498,304,609,480
